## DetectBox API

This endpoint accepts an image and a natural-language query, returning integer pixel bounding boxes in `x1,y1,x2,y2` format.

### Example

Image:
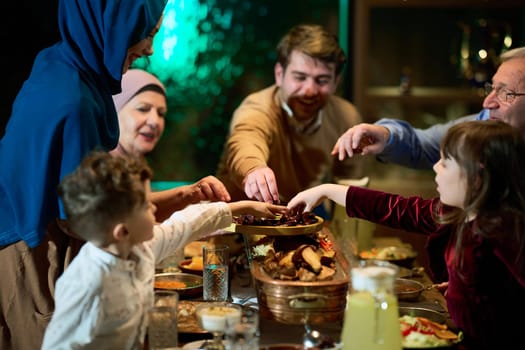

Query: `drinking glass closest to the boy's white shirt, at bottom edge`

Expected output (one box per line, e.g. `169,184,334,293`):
148,290,179,350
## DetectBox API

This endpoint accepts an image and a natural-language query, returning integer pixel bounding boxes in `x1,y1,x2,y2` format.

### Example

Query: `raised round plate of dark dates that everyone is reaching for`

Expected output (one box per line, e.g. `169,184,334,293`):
232,212,324,236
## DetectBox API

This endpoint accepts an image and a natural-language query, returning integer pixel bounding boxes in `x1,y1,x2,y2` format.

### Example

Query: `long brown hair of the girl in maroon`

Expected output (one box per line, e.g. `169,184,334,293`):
439,121,525,268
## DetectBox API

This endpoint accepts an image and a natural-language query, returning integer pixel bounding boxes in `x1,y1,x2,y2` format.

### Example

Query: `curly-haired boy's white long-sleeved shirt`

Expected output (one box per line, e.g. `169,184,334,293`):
42,202,232,350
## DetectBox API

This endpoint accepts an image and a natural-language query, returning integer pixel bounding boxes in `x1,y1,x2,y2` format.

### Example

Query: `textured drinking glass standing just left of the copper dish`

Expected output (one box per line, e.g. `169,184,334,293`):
202,245,230,301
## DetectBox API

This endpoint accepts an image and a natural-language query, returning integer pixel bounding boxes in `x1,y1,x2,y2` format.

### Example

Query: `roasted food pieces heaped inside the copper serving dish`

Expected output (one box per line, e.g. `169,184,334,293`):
251,232,336,282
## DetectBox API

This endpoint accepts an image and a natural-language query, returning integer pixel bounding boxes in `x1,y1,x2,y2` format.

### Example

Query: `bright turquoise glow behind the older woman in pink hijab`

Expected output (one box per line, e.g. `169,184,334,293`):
135,0,243,107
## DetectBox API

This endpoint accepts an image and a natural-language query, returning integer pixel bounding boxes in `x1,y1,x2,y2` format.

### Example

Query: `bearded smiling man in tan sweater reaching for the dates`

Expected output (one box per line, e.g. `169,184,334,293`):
217,25,362,216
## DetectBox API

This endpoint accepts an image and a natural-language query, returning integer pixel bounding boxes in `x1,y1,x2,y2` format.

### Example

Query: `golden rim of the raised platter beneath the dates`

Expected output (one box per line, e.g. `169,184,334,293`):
230,215,324,236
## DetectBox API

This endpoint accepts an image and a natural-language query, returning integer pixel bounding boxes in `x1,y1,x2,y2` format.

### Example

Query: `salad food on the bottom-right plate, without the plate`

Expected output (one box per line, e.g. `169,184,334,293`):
399,315,461,349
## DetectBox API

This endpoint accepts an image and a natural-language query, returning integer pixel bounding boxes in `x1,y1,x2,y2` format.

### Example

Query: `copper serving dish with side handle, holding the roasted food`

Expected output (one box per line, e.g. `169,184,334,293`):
252,229,350,326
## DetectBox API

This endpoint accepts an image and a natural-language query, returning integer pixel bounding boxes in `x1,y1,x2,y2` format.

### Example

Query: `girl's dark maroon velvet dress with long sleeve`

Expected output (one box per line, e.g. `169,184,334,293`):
346,186,525,349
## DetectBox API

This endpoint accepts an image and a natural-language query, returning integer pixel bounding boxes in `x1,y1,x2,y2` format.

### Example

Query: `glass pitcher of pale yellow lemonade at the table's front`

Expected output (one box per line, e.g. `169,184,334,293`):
341,260,402,350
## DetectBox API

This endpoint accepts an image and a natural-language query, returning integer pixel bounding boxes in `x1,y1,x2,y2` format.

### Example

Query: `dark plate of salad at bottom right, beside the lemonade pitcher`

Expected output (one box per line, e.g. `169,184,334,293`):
399,307,463,349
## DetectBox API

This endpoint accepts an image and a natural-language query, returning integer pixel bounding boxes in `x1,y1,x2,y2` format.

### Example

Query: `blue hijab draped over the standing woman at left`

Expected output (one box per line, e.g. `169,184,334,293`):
0,0,166,247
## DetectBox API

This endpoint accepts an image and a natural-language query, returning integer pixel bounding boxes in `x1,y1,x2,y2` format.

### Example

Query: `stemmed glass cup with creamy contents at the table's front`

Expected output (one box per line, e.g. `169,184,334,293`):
195,302,242,350
